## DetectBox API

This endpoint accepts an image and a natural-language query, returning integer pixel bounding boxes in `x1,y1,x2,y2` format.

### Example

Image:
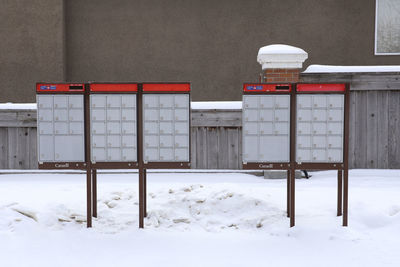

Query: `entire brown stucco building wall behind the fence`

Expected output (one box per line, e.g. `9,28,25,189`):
0,0,400,102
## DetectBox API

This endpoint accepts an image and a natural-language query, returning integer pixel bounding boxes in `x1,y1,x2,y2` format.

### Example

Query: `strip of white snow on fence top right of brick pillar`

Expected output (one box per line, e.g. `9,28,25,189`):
303,65,400,73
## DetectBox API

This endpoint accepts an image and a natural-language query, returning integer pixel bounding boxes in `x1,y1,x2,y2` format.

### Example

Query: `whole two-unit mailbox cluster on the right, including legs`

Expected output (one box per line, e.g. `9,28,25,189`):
242,83,349,226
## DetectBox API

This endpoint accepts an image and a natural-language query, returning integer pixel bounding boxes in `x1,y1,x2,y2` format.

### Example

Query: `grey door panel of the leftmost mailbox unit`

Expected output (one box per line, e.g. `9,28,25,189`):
37,94,85,162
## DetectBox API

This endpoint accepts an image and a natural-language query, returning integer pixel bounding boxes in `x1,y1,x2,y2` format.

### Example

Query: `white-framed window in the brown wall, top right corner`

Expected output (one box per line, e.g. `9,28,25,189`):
375,0,400,55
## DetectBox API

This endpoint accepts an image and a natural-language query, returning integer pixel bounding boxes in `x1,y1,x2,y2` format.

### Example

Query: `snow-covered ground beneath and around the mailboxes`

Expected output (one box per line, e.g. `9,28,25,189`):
0,170,400,267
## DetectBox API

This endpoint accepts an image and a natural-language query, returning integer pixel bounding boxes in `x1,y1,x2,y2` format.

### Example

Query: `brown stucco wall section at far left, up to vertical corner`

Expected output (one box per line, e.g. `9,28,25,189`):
0,0,65,102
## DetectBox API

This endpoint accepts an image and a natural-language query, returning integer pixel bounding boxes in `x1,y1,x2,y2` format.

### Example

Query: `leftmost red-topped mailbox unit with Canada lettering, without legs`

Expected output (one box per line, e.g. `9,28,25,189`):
36,83,86,169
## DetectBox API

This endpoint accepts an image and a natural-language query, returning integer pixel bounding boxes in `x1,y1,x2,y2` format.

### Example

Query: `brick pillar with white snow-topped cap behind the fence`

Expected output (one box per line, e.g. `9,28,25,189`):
257,44,308,83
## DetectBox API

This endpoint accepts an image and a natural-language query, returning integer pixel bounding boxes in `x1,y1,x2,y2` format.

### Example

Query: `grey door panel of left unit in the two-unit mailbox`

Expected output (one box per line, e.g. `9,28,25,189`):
243,95,290,163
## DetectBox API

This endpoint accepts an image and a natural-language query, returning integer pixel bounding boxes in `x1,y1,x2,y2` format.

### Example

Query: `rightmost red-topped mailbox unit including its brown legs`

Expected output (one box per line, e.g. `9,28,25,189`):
289,83,350,226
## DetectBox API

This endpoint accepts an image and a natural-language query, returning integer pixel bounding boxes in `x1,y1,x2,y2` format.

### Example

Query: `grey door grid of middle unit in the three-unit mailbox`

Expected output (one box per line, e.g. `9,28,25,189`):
90,94,137,163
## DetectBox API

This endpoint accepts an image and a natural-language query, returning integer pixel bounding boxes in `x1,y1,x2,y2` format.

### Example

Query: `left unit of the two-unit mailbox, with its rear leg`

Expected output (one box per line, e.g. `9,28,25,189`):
242,83,294,220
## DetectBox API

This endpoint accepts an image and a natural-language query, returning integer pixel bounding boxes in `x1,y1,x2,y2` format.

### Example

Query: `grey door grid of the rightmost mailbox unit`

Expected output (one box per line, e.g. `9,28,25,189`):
296,94,344,163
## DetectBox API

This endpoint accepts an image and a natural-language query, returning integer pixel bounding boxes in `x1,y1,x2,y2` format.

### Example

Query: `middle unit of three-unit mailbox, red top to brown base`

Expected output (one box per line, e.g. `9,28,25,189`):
90,83,138,169
